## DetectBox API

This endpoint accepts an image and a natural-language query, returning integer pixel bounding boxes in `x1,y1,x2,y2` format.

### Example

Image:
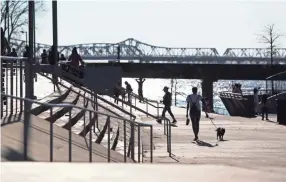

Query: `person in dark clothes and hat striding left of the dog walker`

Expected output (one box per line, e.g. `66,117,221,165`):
157,87,177,124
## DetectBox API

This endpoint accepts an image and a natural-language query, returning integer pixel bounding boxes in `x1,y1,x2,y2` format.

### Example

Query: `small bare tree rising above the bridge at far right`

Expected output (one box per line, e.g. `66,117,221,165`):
259,24,282,66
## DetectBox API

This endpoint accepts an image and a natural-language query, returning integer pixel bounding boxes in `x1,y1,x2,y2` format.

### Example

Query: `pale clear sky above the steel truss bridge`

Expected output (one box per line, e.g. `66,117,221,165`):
36,0,286,52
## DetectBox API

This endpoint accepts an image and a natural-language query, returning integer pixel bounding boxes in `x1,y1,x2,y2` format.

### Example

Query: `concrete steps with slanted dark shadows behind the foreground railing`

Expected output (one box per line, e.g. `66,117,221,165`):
25,84,144,162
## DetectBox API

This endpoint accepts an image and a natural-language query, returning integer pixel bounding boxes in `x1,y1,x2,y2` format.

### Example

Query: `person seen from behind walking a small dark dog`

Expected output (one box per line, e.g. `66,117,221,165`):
186,87,206,141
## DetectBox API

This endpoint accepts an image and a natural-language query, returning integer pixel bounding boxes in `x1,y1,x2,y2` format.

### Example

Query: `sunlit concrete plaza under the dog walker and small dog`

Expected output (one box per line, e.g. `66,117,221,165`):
142,110,286,169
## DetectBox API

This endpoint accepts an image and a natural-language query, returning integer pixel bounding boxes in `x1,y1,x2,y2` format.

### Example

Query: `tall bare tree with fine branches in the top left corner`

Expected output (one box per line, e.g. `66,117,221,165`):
1,1,44,44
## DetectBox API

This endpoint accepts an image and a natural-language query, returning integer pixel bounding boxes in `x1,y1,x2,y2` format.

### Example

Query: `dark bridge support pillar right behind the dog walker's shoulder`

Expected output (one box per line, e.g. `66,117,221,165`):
202,78,214,112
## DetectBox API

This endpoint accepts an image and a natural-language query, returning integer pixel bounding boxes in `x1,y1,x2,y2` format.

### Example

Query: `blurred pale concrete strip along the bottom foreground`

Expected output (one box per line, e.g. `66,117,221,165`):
1,163,286,182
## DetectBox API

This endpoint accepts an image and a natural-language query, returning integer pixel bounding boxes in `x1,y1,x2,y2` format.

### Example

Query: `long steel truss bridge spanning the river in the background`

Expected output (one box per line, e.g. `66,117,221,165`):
8,38,286,65
